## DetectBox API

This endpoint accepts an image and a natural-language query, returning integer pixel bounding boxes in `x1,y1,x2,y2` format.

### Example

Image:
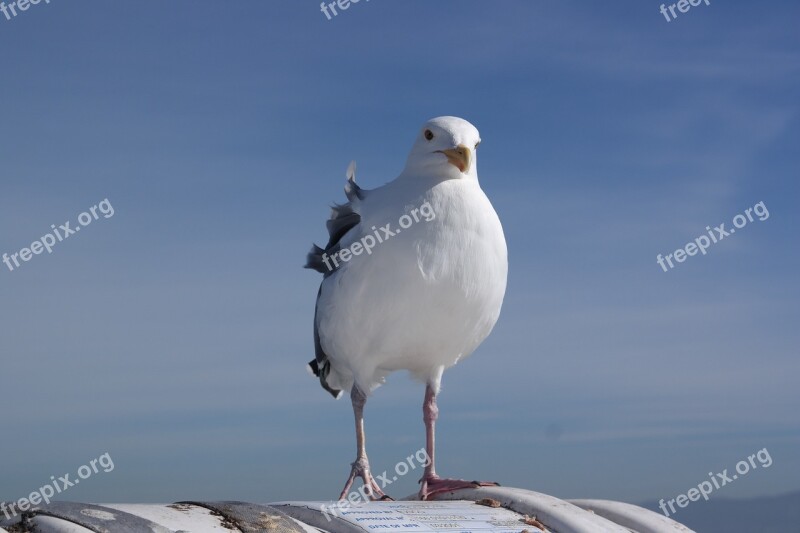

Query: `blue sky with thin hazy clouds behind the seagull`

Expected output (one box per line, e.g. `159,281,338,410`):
0,0,800,508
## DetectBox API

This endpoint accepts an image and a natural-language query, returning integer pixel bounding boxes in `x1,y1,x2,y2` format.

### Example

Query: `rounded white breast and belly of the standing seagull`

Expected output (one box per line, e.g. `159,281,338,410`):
318,180,508,390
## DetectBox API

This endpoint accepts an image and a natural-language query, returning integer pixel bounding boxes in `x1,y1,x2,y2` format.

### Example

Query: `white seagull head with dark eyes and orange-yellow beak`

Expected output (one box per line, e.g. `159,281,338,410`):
404,117,481,179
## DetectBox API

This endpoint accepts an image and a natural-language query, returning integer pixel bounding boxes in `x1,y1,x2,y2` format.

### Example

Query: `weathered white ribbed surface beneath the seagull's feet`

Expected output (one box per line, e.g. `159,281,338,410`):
0,487,693,533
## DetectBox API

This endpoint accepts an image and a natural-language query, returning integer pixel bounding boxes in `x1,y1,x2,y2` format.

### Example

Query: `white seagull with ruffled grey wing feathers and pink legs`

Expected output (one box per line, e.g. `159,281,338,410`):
305,116,508,500
